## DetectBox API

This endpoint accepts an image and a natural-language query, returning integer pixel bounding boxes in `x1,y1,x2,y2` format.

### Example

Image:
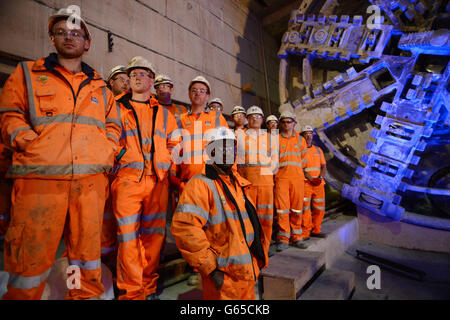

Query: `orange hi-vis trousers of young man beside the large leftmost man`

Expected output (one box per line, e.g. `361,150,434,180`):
111,175,169,300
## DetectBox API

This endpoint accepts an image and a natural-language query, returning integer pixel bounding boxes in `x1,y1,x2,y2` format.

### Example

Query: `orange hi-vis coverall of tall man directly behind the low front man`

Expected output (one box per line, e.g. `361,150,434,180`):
177,110,228,194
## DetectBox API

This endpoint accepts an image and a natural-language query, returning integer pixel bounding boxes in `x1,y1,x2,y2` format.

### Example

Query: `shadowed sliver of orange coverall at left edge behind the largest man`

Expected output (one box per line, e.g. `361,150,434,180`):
0,139,12,240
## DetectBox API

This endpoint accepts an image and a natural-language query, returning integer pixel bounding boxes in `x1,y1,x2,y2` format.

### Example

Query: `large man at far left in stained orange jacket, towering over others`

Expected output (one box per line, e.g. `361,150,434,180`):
0,8,121,300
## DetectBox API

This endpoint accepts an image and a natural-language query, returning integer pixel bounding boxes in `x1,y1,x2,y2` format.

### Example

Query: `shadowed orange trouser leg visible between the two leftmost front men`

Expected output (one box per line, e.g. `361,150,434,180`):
102,176,117,256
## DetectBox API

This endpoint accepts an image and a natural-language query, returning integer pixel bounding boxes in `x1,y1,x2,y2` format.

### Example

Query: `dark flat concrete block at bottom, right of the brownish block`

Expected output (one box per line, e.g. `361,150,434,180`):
298,269,355,300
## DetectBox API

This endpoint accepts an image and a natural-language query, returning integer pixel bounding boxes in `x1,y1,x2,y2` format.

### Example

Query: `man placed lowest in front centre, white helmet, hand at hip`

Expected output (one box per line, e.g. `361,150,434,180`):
171,127,268,300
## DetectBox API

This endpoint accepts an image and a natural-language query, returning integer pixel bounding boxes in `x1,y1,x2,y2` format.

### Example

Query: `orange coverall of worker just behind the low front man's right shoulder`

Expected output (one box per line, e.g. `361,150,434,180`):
237,129,278,251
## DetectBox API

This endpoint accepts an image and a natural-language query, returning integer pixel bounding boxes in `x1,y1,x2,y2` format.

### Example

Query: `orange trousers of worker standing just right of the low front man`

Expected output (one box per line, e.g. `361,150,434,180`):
247,185,274,251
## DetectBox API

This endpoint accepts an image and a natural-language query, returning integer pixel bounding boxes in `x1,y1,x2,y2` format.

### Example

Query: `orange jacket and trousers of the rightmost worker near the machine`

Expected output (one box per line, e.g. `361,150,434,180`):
302,145,326,238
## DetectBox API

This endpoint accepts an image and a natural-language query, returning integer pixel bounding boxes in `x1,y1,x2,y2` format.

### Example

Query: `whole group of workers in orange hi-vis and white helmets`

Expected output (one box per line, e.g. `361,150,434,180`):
0,9,326,300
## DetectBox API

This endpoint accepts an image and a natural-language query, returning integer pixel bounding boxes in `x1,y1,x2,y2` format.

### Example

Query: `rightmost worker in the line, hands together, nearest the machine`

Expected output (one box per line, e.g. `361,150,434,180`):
301,125,327,239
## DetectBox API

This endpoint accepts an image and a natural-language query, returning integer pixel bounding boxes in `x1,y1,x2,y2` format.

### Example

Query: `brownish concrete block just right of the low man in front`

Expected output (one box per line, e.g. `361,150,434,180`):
261,248,325,300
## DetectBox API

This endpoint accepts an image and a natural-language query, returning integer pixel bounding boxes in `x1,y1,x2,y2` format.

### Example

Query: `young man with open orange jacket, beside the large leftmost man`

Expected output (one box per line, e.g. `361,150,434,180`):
111,56,179,300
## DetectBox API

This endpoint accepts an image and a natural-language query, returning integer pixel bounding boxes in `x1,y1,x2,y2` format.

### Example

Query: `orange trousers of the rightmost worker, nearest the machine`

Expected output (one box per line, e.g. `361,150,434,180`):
302,182,325,238
